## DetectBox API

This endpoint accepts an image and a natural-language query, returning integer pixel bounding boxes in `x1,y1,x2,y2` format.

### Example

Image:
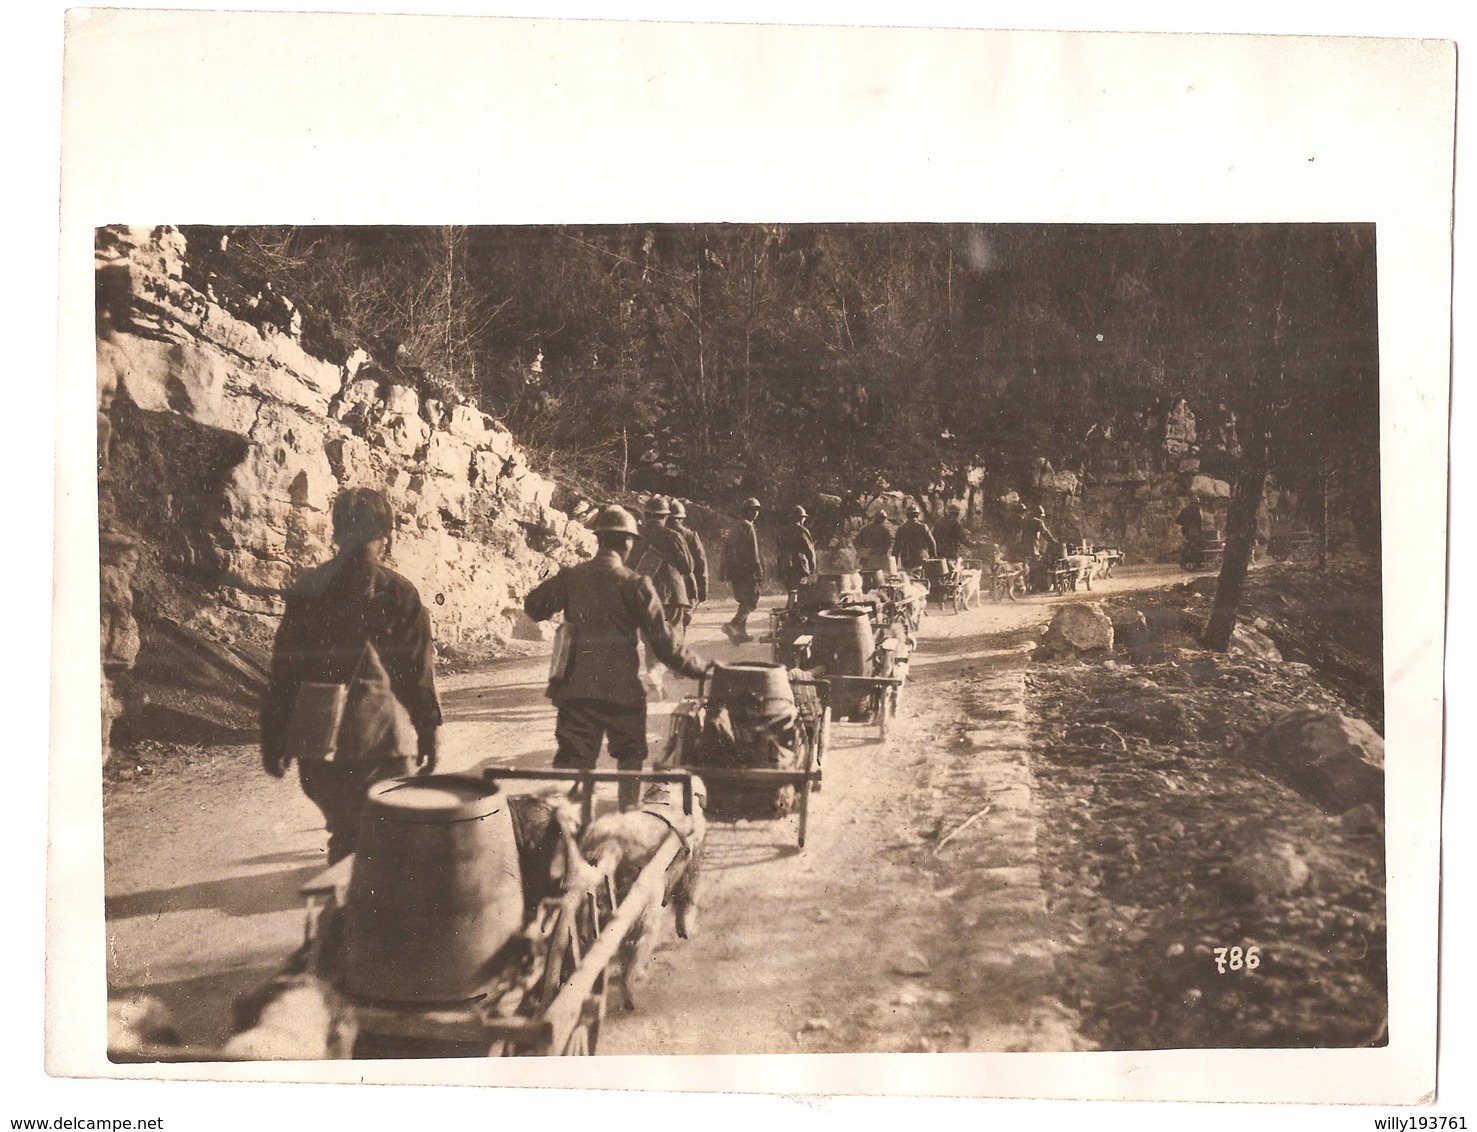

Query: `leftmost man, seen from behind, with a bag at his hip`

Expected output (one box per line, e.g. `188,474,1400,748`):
261,488,442,865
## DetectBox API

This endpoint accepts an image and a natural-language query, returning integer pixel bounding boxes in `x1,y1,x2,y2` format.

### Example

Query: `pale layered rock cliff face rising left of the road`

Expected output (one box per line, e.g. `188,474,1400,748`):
96,226,594,756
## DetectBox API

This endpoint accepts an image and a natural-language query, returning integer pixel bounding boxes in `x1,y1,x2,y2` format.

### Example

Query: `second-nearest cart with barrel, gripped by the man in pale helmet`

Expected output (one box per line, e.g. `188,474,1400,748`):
663,661,830,848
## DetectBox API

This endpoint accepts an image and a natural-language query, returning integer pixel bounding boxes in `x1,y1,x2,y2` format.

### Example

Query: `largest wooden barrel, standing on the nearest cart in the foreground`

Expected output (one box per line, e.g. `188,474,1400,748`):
344,774,523,1003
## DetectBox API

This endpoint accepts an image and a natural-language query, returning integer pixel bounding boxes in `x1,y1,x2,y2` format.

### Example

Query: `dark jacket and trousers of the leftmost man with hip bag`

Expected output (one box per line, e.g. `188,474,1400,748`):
261,557,442,865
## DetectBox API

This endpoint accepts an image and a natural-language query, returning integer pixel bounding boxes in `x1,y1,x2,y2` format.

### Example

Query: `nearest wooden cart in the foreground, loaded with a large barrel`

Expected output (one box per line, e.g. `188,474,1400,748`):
294,768,693,1058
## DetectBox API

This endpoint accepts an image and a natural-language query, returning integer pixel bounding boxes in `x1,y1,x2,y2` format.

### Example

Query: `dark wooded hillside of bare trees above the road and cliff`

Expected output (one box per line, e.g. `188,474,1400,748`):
185,225,1380,547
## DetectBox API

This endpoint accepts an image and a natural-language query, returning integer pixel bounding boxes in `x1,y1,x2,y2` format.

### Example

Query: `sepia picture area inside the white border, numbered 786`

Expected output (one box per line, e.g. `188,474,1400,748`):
97,225,1387,1060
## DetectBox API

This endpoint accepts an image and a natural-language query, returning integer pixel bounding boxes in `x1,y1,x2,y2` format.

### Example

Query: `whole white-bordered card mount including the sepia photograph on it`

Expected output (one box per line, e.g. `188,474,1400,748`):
47,10,1455,1104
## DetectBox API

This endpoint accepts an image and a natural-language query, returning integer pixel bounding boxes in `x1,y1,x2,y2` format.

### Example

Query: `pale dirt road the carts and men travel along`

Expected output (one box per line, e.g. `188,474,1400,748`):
103,570,1183,1054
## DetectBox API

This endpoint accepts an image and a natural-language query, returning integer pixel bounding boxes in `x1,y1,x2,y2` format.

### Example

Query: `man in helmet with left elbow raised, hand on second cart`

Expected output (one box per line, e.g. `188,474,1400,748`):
523,507,705,810
